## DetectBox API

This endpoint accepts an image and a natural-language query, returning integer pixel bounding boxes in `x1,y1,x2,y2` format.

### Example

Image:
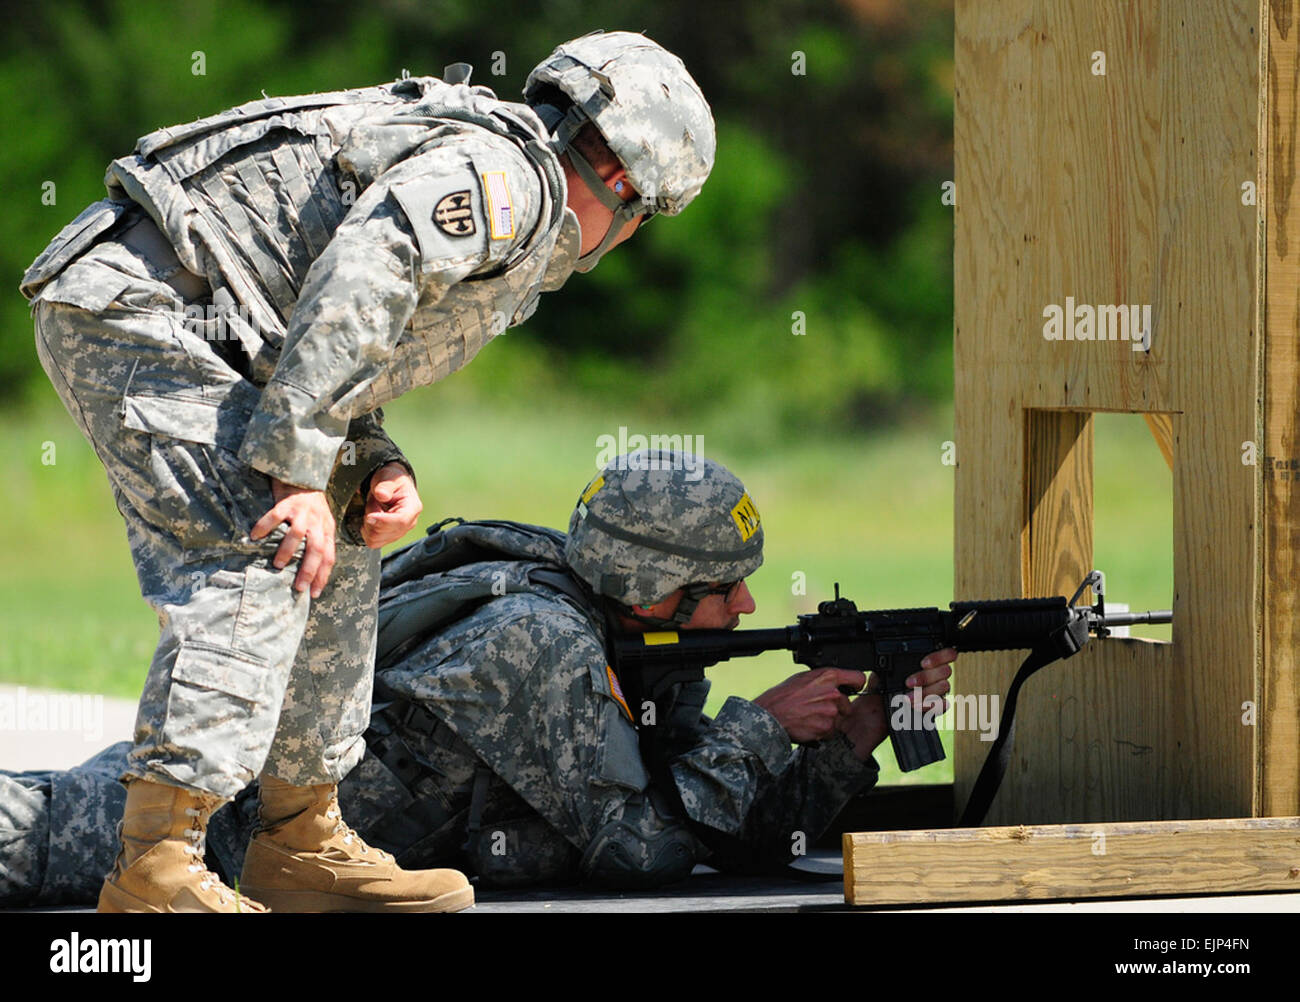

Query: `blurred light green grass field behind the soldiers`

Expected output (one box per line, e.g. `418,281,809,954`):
0,379,1173,782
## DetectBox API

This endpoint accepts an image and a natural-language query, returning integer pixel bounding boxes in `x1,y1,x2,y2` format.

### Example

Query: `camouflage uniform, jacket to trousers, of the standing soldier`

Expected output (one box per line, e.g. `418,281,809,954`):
22,70,580,797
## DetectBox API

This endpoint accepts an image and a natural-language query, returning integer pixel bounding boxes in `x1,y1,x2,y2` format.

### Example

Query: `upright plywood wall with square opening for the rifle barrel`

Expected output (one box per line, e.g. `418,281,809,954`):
954,0,1300,824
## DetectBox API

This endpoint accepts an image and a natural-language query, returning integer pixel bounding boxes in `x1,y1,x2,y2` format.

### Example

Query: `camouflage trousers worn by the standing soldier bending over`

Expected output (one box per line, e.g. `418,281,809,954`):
34,218,380,798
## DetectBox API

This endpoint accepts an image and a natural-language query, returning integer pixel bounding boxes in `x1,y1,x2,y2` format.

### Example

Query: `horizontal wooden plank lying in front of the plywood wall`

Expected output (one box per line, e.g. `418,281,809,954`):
844,817,1300,905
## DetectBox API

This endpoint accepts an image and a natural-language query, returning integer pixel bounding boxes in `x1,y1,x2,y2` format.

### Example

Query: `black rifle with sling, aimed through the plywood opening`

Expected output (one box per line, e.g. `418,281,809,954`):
614,571,1173,824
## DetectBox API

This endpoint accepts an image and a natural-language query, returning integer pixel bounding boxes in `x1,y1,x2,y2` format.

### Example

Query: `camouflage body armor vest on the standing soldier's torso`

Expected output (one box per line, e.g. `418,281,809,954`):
105,77,567,418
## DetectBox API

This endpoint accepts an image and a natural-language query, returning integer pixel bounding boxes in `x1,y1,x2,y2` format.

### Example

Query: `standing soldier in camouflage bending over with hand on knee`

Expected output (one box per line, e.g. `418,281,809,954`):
22,31,715,911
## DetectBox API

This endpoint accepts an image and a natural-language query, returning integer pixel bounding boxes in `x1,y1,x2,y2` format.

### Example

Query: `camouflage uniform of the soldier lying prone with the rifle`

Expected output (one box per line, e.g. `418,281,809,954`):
0,522,878,905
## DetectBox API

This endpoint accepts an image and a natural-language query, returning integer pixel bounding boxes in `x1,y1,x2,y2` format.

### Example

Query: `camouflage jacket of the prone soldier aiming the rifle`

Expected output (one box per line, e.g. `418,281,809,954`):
377,524,878,882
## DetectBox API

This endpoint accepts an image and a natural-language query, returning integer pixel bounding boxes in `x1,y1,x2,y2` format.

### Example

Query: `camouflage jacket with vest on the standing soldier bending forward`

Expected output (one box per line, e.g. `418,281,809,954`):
23,77,581,490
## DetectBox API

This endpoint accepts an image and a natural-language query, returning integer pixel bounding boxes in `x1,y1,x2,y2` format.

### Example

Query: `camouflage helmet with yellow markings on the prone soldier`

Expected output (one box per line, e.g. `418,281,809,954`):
564,450,763,626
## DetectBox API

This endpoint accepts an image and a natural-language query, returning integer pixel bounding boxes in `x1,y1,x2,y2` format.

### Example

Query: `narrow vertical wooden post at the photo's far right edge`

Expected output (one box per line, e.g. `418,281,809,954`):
1256,0,1300,815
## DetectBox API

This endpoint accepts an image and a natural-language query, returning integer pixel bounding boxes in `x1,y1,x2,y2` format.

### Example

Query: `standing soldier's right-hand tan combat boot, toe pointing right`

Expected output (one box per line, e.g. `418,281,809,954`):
239,775,475,911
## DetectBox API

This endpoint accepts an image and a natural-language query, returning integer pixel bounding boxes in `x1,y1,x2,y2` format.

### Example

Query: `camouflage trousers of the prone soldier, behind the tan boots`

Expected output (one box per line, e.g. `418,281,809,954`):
0,736,580,908
